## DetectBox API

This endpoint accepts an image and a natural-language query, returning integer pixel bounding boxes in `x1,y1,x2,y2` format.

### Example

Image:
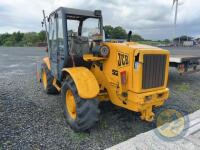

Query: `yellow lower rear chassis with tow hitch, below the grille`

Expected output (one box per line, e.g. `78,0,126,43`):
98,85,169,122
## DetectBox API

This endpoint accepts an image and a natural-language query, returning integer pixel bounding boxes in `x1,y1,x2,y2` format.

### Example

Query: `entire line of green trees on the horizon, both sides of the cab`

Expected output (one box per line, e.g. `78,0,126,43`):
0,25,170,46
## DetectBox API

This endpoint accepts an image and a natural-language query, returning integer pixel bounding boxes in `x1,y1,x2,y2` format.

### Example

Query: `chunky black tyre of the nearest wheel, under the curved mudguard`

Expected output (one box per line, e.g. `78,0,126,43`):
61,77,100,132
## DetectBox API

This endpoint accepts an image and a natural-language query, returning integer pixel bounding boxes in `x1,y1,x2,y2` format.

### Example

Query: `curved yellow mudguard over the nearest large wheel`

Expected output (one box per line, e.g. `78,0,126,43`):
62,67,99,99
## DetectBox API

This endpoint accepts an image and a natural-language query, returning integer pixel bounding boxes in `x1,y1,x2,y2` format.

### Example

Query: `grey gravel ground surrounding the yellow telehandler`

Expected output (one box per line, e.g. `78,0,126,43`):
0,48,200,150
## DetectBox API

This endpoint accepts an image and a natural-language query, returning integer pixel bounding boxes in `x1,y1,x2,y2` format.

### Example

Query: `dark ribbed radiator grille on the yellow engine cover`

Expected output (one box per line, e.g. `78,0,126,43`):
142,54,166,89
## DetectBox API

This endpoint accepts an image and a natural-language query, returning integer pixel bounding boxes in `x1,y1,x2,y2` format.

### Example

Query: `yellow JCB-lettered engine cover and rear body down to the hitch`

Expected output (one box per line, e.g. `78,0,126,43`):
91,42,169,121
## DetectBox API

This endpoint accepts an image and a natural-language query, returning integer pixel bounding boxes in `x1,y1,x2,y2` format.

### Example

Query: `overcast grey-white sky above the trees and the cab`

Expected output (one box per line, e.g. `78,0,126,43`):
0,0,200,39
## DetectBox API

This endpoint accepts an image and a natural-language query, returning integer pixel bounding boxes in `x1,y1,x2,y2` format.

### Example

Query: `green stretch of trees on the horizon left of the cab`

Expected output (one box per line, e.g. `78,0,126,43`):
0,31,46,46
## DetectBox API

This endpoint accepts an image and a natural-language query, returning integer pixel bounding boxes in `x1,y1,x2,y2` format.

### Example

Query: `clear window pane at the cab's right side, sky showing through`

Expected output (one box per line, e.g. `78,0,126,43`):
81,18,101,39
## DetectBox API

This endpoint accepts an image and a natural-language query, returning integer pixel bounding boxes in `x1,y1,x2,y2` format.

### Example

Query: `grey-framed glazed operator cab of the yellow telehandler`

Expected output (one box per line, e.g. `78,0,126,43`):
48,7,103,80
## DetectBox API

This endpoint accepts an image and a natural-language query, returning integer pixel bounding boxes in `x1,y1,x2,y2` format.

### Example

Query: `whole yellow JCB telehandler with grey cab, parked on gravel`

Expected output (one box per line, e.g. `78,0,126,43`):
41,7,169,131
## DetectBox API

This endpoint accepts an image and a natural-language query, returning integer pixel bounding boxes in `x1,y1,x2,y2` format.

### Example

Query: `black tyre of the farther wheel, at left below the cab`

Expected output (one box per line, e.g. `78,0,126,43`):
41,63,59,94
